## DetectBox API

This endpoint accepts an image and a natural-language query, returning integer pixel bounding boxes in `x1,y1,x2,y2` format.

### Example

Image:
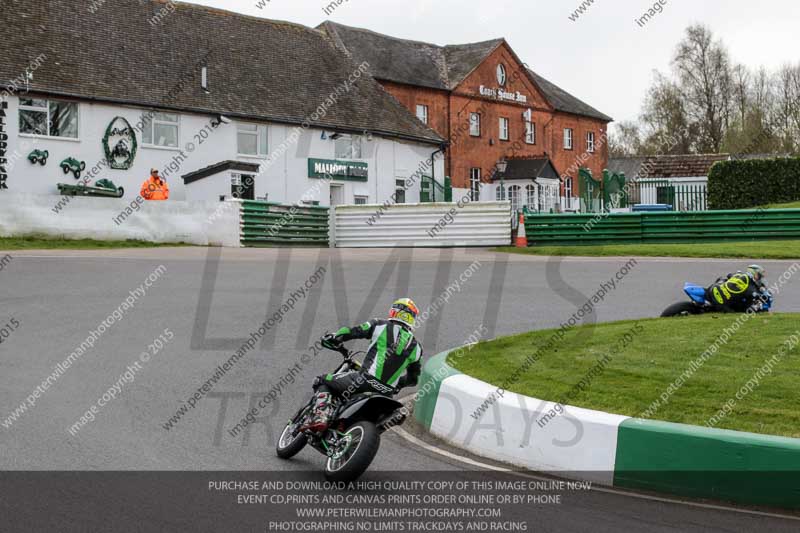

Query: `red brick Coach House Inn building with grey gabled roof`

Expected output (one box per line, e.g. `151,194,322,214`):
319,22,612,210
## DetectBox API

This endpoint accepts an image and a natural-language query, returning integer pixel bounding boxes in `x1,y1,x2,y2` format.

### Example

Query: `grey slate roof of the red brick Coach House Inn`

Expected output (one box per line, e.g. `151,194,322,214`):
319,21,613,122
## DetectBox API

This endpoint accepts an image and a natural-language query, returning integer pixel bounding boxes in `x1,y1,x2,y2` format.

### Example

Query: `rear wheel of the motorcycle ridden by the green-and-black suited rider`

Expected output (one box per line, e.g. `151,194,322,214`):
325,422,381,482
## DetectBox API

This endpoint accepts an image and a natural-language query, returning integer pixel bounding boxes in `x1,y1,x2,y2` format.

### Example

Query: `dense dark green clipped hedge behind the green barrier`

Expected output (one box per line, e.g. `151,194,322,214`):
708,158,800,209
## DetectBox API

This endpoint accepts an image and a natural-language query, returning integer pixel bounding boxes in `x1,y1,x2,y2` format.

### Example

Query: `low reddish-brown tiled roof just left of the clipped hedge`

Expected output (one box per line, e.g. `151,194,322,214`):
608,154,731,179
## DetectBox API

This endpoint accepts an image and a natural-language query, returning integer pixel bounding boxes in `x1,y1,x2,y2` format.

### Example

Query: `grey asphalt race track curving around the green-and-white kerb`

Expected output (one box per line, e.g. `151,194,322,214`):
0,248,800,532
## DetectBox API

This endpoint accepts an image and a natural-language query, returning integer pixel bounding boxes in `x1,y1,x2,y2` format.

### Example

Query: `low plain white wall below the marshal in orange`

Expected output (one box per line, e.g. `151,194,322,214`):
0,192,240,247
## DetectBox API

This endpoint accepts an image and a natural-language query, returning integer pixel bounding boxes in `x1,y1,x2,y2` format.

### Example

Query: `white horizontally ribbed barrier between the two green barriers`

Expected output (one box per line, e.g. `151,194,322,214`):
332,202,511,248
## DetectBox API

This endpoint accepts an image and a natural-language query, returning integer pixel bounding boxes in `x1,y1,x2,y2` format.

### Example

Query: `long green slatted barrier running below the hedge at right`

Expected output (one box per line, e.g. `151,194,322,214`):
525,209,800,246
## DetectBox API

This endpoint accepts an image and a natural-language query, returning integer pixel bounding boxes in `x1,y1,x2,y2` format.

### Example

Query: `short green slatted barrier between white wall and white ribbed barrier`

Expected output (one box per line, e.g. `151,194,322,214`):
241,200,330,247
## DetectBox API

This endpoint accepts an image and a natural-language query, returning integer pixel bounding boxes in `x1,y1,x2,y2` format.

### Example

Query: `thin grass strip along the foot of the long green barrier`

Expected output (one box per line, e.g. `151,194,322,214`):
495,240,800,259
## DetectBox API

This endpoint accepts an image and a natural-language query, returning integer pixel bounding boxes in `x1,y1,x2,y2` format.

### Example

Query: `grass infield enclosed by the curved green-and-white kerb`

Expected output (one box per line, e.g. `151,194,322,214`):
448,314,800,437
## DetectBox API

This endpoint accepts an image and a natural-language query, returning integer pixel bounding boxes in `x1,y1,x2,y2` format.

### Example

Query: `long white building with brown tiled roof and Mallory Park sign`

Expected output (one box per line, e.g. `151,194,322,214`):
0,0,444,205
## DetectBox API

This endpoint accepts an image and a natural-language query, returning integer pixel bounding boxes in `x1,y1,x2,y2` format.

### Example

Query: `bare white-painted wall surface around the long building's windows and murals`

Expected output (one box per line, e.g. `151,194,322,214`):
0,97,444,205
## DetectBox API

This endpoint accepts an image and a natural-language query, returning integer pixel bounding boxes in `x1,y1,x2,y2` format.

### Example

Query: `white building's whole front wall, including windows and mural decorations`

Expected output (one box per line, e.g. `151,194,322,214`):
0,95,444,205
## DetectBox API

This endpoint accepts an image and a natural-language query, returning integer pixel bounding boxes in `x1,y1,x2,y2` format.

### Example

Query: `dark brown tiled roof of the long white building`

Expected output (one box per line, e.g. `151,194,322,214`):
0,0,443,144
